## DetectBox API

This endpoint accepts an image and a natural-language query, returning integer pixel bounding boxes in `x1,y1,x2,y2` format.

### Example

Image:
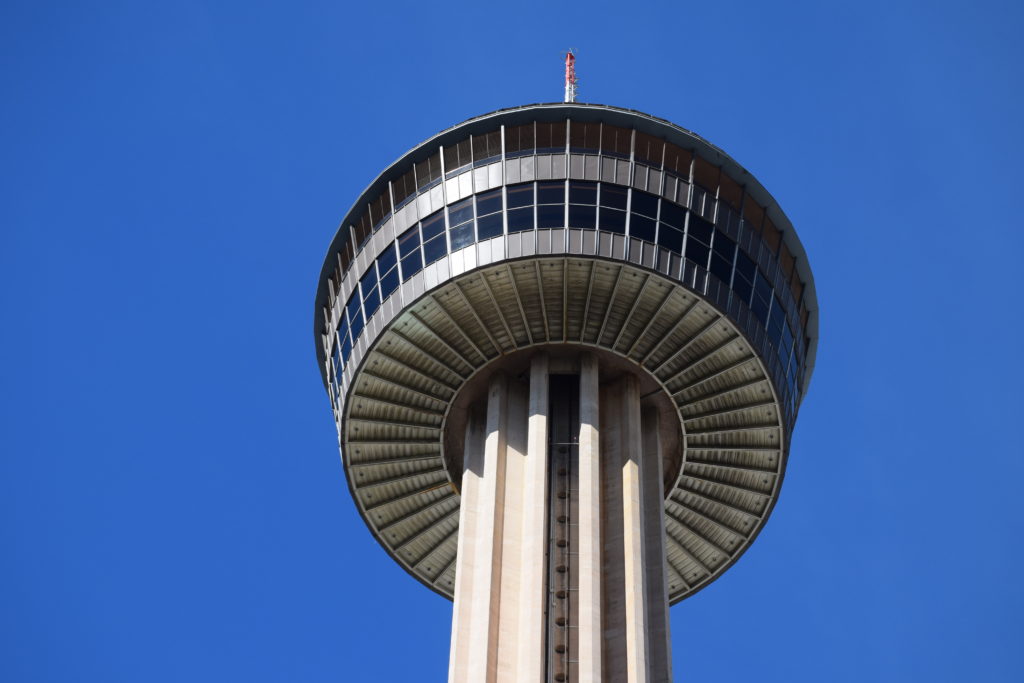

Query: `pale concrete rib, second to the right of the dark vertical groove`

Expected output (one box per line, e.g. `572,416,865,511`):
620,376,650,683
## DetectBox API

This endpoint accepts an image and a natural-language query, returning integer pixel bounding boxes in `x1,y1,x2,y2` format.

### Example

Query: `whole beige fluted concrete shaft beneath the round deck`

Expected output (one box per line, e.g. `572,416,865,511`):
449,350,671,683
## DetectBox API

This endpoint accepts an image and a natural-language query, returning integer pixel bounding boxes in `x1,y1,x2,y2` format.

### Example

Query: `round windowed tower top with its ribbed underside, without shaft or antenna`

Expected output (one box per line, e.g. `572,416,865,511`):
313,103,818,603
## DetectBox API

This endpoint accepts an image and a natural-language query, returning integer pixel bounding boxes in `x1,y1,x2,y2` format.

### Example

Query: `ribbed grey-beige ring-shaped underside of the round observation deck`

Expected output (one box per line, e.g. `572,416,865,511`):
342,257,785,602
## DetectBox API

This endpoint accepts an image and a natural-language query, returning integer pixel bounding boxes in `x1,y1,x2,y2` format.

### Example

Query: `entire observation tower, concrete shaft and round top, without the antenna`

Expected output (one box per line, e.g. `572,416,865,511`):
313,98,817,683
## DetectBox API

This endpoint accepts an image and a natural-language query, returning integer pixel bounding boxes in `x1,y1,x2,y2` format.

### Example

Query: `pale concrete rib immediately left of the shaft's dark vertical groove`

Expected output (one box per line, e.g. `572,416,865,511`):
513,353,550,682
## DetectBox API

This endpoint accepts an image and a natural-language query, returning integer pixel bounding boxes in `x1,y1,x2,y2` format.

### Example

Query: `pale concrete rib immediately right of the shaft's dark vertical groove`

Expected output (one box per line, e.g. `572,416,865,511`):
574,353,603,683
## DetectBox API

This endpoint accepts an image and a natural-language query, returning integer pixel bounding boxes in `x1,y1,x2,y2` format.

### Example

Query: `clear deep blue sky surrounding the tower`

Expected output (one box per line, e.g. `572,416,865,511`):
0,0,1024,683
